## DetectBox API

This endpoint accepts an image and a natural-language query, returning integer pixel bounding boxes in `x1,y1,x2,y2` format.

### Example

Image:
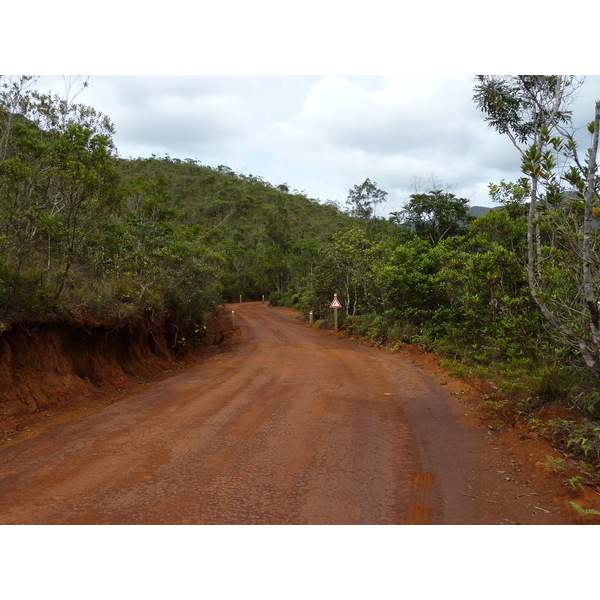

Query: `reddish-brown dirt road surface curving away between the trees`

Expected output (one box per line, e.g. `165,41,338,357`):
0,303,584,524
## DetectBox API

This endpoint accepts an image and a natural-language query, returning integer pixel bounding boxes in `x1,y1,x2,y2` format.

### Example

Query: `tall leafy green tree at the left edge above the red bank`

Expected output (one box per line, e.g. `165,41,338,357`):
0,77,118,311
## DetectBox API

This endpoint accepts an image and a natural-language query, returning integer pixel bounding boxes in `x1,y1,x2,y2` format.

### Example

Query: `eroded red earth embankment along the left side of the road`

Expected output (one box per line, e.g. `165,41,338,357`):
0,310,228,443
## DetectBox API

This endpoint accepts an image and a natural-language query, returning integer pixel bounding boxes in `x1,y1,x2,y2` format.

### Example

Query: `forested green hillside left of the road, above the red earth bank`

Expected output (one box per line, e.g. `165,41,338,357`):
0,80,350,326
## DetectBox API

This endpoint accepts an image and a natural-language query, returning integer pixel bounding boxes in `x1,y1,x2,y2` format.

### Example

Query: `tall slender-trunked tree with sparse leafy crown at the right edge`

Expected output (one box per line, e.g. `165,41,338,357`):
474,75,600,376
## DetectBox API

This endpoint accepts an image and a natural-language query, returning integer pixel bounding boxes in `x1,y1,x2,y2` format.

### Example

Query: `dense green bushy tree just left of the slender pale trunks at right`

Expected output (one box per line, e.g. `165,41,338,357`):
432,208,540,364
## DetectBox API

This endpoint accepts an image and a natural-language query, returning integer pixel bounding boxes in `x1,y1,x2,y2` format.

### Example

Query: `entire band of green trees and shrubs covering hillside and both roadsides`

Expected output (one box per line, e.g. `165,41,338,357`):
0,77,600,484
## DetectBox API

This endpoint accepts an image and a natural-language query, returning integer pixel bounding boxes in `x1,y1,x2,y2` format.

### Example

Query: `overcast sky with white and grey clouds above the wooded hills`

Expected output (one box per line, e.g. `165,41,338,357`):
31,74,600,212
